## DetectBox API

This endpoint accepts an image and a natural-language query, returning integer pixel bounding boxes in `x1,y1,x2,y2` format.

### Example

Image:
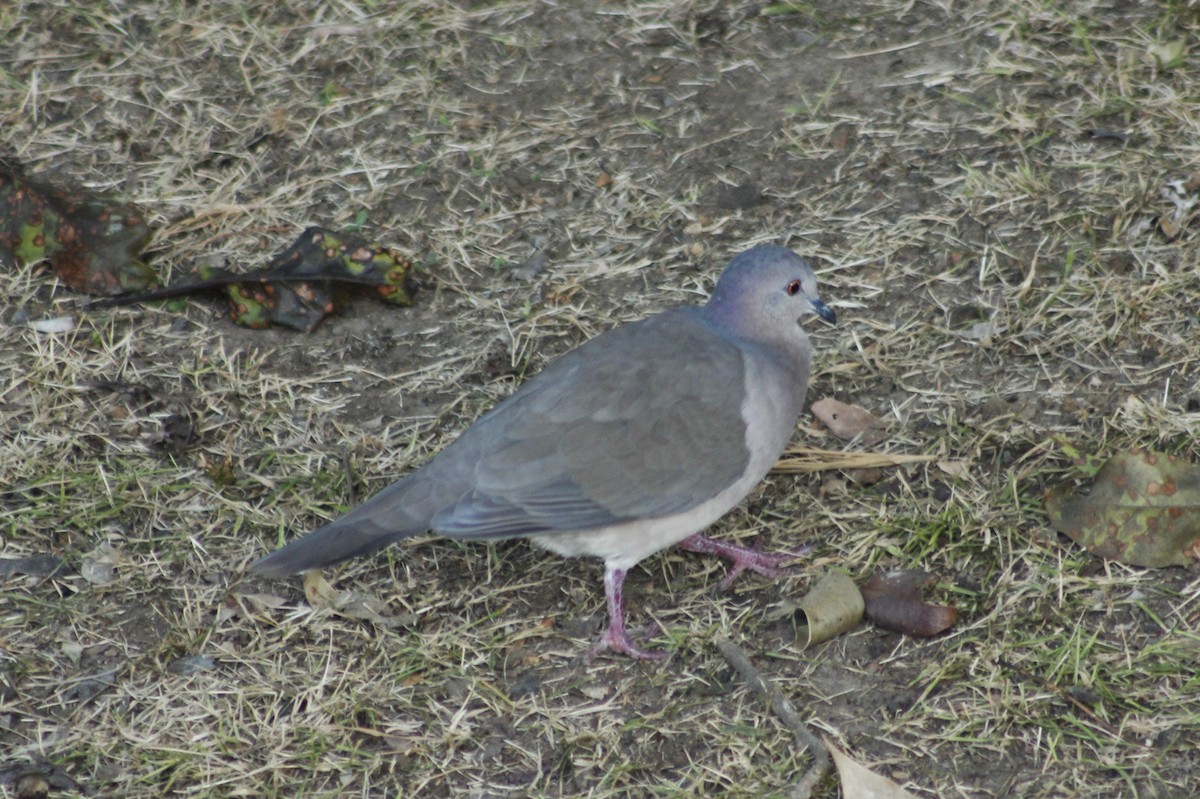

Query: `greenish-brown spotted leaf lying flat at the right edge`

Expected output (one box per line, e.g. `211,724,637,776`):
1045,449,1200,566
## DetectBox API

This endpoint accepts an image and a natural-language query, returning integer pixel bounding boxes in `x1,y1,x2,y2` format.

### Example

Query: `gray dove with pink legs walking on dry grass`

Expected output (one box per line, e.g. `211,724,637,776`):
253,245,835,659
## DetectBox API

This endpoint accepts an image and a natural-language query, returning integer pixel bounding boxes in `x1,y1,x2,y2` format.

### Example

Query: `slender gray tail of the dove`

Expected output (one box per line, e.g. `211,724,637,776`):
251,480,430,577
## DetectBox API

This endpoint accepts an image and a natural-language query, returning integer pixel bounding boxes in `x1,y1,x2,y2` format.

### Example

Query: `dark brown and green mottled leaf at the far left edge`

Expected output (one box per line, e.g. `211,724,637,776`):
0,158,158,294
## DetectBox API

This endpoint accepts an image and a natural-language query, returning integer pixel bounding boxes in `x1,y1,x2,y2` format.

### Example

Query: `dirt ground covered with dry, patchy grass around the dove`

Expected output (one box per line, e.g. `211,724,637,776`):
0,0,1200,799
